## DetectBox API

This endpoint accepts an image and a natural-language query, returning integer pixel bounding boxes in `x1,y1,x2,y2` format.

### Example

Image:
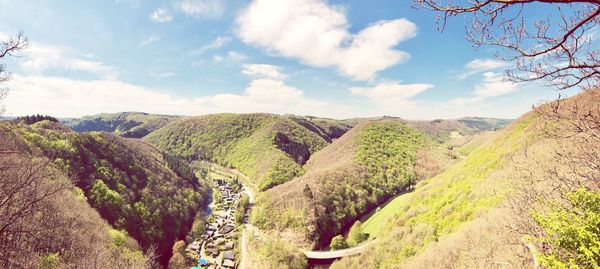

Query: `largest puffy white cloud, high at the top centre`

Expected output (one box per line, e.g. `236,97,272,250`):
237,0,417,80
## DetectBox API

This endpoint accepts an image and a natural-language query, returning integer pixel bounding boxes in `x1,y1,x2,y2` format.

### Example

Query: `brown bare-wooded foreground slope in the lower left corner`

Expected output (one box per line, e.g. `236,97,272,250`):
0,124,154,268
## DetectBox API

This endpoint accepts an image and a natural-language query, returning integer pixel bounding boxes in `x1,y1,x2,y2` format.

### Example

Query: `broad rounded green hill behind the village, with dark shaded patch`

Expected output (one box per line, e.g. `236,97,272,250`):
144,114,328,190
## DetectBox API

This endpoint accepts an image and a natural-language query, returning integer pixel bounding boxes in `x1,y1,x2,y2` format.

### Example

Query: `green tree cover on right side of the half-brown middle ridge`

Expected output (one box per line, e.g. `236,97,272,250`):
313,121,433,244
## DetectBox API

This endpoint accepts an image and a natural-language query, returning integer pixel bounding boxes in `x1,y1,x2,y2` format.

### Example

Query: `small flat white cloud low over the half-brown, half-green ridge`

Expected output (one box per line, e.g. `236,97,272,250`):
350,82,433,108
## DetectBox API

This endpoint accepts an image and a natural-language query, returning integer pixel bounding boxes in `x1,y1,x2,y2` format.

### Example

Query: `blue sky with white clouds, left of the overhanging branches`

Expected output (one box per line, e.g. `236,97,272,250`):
0,0,576,119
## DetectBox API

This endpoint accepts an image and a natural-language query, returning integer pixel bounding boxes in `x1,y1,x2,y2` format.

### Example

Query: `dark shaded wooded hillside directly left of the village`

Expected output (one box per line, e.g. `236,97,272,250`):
17,121,207,264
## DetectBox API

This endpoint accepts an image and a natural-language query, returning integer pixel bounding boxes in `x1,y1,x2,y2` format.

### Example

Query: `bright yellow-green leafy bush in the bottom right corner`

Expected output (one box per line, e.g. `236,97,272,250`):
533,189,600,268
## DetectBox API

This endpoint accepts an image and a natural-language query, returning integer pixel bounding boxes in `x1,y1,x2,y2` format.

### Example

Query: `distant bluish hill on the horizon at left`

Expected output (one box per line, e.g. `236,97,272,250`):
61,112,179,138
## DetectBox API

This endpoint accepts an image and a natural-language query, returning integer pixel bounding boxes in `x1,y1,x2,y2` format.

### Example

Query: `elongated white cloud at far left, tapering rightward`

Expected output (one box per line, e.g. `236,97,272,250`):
21,43,117,77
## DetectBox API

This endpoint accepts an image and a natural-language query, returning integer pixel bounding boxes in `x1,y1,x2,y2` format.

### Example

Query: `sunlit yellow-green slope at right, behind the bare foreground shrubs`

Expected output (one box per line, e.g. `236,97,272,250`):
332,110,536,268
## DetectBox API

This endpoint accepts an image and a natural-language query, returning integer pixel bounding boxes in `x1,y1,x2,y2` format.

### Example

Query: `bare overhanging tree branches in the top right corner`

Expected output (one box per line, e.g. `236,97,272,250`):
415,0,600,89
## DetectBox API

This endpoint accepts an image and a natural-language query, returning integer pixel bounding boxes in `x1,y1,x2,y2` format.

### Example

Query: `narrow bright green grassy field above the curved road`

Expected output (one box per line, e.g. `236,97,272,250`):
361,193,412,238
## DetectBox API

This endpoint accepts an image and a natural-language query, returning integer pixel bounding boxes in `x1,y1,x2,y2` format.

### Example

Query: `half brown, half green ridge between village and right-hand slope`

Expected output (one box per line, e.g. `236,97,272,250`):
252,120,452,246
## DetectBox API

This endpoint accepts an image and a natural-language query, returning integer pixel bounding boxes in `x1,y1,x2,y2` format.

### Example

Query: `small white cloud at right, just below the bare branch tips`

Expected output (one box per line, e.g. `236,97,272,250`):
451,72,518,104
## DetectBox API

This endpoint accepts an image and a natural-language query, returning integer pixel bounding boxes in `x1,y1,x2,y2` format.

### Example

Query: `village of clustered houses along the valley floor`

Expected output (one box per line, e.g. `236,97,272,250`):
186,179,250,269
